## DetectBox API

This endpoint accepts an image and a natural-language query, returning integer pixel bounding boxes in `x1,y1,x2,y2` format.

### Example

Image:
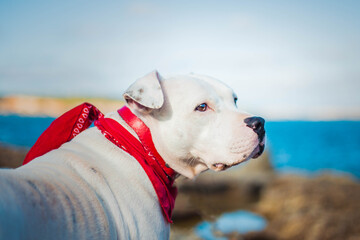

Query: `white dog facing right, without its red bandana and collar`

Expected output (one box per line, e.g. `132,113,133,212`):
0,71,265,239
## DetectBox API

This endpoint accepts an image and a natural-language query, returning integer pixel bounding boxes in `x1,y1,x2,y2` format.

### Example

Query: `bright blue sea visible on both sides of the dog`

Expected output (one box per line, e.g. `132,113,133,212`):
0,115,360,178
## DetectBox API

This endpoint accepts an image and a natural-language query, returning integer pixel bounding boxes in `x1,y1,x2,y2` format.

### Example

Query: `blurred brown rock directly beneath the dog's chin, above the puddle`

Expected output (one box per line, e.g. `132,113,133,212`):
173,154,275,228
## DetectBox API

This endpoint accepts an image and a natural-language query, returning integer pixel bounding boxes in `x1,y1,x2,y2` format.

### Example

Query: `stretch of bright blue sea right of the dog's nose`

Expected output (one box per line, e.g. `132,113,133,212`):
266,121,360,178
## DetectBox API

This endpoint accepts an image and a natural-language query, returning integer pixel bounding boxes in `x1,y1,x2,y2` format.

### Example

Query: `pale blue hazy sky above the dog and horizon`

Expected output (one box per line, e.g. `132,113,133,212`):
0,0,360,120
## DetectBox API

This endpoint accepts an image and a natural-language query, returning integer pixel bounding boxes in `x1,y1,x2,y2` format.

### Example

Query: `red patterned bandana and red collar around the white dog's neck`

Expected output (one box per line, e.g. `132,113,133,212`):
23,103,177,223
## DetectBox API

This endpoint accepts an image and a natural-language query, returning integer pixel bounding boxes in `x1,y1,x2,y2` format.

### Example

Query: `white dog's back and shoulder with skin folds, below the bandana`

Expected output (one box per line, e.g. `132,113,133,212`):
0,124,169,239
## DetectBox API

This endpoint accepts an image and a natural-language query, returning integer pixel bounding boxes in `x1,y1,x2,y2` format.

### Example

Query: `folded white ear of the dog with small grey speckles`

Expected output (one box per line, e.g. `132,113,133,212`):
123,70,164,111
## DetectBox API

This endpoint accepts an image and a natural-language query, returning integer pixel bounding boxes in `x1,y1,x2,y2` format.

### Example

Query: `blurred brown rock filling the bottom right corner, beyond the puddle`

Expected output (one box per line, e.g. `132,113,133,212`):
256,175,360,240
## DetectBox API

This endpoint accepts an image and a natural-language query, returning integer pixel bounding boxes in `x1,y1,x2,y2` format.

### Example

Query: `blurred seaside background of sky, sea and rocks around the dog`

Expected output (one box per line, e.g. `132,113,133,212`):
0,0,360,239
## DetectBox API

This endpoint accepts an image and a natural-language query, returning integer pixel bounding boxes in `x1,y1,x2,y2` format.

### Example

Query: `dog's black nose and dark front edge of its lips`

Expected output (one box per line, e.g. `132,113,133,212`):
244,117,265,158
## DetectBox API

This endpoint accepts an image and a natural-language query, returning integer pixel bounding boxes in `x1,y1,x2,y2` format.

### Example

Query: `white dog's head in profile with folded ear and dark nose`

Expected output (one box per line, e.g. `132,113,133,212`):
124,71,265,178
